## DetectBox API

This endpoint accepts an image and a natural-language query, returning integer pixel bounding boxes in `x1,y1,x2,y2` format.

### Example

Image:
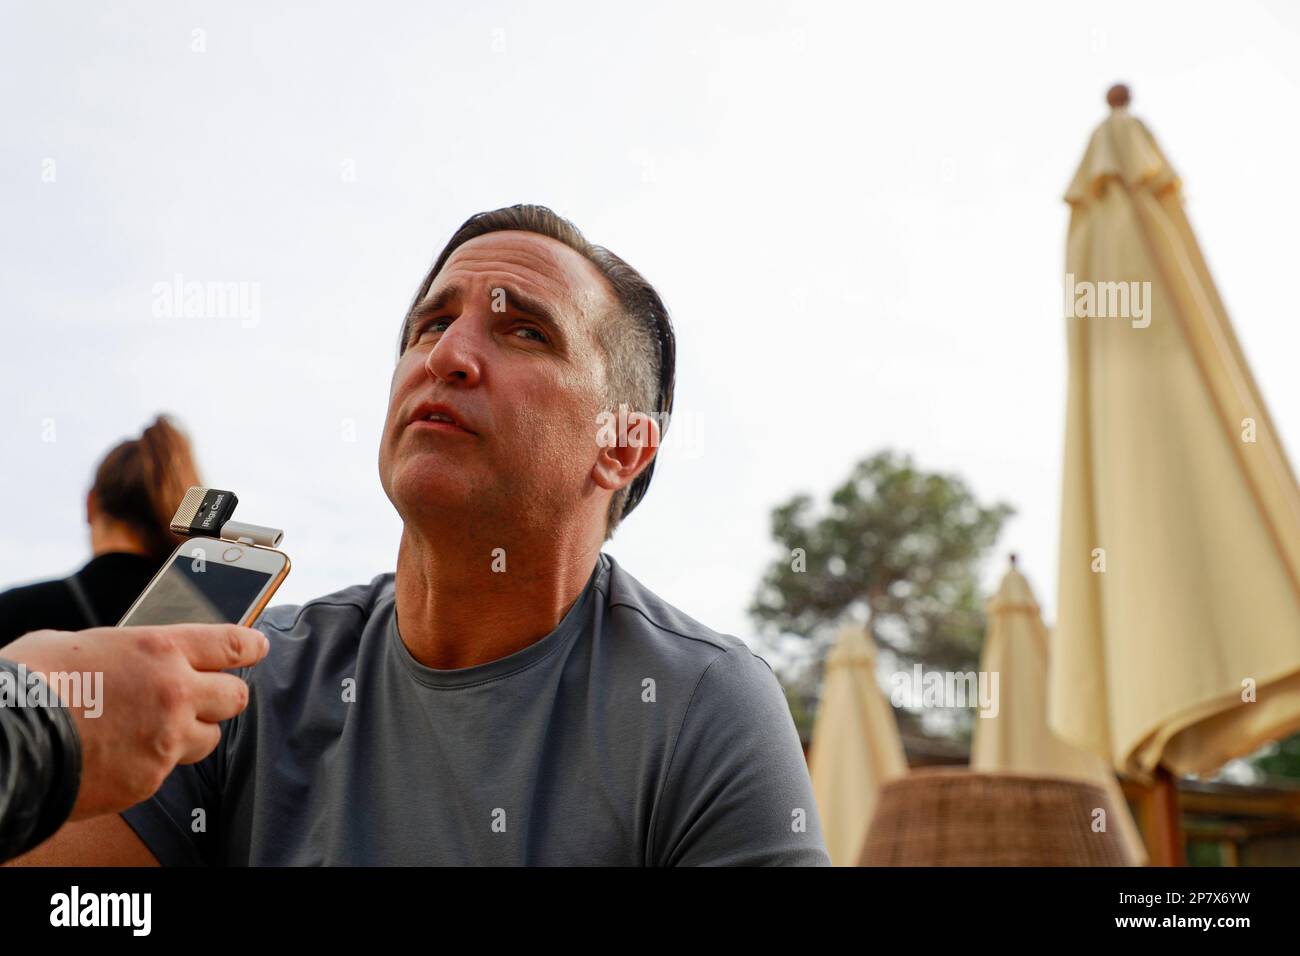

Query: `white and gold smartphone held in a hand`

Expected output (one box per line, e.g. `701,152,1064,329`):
117,537,290,627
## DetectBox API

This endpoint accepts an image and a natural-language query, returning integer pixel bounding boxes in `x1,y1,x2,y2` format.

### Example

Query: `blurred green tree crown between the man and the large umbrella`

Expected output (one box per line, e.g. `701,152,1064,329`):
749,450,1014,732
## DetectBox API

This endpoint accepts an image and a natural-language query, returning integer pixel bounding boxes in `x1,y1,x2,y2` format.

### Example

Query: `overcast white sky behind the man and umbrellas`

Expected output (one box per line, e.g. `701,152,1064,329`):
0,0,1300,658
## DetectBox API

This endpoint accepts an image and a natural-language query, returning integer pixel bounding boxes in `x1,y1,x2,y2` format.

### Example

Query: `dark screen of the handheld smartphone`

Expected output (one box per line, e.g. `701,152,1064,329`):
122,555,270,626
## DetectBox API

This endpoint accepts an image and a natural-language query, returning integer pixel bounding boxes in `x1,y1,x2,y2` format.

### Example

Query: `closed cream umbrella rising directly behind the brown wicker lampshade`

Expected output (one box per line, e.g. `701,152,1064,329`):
971,557,1149,865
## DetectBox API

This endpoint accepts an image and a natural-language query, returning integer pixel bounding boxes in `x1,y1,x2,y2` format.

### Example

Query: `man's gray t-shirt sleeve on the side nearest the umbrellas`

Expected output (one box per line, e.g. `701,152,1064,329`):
650,648,831,866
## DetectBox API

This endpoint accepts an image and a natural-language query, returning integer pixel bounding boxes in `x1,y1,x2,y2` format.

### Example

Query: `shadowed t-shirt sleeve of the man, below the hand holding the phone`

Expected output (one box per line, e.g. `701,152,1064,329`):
121,667,251,866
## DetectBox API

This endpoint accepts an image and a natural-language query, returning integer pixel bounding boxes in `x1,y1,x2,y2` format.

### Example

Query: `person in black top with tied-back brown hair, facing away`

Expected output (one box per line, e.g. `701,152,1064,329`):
0,415,202,644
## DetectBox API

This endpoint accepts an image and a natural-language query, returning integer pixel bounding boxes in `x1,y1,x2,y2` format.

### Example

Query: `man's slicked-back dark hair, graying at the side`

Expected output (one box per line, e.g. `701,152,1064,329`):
398,204,677,540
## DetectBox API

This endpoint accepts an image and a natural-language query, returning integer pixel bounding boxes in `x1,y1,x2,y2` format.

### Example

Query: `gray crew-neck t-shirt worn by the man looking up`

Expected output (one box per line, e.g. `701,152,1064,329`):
122,553,831,866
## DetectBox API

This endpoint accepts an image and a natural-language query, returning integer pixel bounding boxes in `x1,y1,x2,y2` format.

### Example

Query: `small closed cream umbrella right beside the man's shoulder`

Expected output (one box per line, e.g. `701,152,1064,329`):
809,626,907,866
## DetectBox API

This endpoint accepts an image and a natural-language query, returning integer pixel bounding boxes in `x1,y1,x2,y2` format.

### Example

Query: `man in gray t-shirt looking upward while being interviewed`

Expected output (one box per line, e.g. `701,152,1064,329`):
33,206,831,866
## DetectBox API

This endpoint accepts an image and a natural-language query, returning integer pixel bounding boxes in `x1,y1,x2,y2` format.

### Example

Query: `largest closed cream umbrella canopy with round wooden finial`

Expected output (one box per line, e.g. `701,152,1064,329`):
1049,87,1300,779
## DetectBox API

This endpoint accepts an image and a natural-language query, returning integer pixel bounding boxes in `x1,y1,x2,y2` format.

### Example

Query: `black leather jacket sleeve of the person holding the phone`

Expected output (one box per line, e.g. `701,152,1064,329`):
0,659,82,862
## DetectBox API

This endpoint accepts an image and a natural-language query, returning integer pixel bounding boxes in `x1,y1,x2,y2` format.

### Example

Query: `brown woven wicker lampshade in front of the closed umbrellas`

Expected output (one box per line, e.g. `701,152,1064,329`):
858,769,1135,866
